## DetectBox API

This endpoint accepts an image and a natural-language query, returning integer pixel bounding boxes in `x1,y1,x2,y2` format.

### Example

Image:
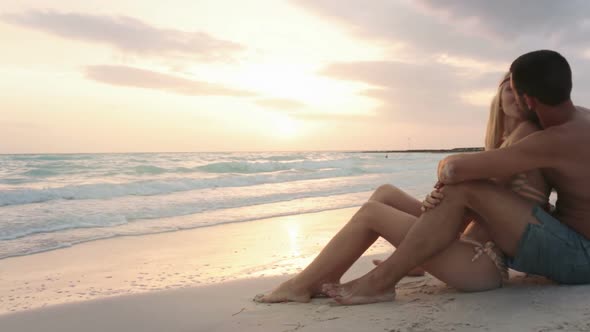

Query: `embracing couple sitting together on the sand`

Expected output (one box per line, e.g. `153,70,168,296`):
255,50,590,304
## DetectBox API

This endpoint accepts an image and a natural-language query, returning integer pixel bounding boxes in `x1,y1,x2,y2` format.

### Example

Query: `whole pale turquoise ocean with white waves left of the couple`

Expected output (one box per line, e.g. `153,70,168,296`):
0,152,447,259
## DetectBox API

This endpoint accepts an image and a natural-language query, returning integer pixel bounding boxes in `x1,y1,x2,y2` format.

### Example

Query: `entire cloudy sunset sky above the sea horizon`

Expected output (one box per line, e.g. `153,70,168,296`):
0,0,590,153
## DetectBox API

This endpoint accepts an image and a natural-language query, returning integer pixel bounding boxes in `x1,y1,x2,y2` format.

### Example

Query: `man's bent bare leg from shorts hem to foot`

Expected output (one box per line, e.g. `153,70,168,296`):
325,181,537,304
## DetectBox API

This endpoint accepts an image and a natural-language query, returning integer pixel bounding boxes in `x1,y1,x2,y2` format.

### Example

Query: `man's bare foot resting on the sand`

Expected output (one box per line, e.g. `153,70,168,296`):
322,278,395,305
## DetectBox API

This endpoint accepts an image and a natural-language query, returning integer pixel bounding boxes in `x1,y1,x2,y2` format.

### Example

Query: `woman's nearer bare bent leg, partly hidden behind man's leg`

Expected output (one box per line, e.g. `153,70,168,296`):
256,200,501,302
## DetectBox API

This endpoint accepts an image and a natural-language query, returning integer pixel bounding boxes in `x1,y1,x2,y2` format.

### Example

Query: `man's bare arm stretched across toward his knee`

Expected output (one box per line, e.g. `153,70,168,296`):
438,129,562,184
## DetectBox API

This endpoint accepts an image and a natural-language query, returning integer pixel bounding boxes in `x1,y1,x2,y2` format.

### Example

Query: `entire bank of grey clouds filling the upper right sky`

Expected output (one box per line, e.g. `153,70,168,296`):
292,0,590,125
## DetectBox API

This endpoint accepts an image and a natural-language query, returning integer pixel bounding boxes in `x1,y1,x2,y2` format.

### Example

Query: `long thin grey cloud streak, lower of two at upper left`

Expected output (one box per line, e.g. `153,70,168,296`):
85,65,256,97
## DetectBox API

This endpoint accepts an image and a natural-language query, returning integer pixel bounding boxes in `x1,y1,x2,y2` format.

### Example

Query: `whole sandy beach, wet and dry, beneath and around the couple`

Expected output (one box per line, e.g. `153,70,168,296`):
0,209,590,331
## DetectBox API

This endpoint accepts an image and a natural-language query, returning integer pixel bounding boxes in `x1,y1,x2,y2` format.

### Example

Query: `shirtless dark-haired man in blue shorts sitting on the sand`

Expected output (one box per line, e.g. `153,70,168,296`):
323,50,590,304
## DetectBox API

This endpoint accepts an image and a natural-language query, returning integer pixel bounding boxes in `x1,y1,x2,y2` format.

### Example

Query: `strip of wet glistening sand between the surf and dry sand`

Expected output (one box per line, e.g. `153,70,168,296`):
0,208,391,314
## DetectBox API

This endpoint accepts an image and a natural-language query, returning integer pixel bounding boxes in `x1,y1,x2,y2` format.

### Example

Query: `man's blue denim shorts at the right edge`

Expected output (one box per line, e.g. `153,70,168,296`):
506,206,590,284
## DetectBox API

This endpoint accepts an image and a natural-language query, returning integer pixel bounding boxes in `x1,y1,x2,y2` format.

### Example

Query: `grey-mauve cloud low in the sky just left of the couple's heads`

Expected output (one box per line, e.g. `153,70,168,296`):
321,61,502,125
